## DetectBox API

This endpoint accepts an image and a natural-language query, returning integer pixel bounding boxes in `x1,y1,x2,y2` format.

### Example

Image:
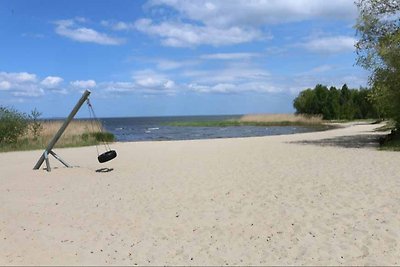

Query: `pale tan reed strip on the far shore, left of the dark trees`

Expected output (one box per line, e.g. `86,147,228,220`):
239,114,323,125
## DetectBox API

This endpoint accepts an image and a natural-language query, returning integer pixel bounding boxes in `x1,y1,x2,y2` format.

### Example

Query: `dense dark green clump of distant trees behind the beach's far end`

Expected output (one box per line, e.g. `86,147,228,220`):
293,84,380,120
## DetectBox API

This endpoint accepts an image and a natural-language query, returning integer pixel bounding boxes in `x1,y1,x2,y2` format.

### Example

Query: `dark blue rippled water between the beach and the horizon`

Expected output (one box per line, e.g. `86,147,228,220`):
100,115,321,142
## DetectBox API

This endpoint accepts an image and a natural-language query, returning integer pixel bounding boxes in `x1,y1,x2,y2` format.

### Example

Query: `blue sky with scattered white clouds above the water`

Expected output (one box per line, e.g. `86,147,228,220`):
0,0,368,118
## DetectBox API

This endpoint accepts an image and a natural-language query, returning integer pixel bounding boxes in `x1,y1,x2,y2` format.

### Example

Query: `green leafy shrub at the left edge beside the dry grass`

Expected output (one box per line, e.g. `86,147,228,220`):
0,107,28,144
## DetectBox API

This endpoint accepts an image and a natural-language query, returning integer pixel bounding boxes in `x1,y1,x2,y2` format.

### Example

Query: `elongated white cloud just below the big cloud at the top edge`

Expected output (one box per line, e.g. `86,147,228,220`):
135,19,264,47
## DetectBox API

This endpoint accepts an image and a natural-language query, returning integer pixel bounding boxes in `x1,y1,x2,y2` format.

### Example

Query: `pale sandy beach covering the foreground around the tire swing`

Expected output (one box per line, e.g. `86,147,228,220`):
0,125,400,265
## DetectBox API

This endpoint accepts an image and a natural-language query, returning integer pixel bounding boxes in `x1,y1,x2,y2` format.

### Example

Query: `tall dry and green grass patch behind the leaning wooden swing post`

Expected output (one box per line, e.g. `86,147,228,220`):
0,120,115,152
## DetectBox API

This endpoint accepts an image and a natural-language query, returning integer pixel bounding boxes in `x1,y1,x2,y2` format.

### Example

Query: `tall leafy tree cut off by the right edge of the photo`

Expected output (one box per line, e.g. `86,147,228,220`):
356,0,400,127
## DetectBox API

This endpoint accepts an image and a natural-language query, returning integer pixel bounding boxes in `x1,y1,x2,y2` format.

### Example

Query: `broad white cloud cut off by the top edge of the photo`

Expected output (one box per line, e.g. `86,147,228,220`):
147,0,357,27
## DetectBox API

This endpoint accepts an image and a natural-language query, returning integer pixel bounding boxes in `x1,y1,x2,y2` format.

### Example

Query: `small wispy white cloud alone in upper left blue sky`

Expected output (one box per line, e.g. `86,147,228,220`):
55,19,124,45
